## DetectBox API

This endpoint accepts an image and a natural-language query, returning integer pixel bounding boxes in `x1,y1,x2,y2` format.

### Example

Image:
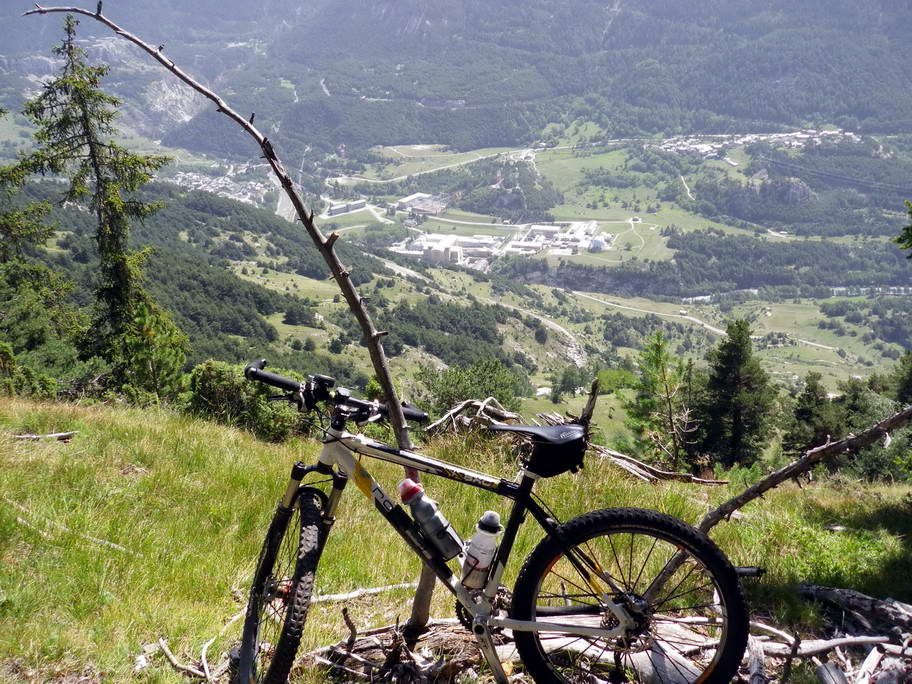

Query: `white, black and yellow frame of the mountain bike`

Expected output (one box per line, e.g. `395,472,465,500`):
283,426,633,684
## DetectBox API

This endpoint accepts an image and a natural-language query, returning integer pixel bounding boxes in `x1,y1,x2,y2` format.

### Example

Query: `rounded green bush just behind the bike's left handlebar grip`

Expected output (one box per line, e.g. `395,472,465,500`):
184,359,300,442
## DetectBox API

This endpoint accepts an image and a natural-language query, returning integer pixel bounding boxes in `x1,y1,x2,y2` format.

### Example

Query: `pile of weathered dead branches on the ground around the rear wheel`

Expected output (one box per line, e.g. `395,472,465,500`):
299,585,912,684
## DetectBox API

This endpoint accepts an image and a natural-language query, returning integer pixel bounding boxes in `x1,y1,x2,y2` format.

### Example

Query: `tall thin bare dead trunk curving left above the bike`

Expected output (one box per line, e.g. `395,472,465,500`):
25,2,434,627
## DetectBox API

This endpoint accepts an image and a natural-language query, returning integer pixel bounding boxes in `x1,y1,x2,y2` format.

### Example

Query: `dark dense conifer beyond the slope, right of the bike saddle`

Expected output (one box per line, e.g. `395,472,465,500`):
703,320,775,467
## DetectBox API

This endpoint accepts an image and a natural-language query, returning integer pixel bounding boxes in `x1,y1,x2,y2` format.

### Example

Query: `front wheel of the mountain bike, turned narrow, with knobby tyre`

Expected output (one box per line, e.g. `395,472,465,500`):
235,489,323,684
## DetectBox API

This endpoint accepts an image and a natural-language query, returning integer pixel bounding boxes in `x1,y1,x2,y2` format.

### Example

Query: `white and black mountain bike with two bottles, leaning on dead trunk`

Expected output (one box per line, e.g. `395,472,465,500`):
236,360,748,684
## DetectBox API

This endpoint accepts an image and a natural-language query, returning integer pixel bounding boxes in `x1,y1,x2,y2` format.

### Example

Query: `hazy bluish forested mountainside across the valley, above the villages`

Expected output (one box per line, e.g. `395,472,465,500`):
0,0,912,154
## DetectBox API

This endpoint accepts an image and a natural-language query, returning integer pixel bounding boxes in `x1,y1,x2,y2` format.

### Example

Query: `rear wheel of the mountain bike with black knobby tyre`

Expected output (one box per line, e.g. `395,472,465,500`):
511,508,748,684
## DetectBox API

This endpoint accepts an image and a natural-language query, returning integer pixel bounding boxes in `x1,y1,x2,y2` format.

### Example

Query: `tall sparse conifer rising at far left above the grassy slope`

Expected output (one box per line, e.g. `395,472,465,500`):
23,16,187,395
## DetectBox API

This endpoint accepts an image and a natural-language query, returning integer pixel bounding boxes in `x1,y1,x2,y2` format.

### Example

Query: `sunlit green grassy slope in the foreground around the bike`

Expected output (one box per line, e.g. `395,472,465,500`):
0,399,912,682
